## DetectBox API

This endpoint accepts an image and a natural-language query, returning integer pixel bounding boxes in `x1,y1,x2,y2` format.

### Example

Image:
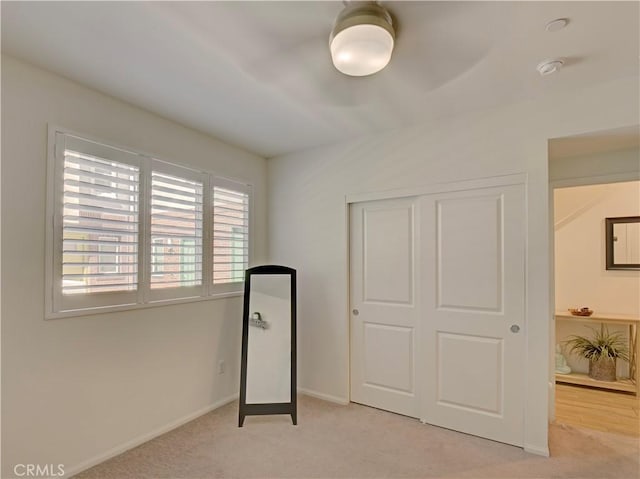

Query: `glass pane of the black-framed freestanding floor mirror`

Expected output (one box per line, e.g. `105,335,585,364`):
246,274,291,404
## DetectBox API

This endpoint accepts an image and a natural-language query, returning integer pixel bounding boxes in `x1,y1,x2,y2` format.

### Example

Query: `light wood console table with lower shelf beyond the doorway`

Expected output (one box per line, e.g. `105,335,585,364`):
555,312,640,395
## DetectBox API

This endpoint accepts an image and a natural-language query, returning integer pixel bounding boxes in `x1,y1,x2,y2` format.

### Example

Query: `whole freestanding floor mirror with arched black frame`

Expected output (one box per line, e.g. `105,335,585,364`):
238,265,297,427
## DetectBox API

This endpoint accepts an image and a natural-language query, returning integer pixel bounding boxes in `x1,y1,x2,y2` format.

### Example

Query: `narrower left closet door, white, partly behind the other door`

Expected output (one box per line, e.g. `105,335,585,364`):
350,199,420,417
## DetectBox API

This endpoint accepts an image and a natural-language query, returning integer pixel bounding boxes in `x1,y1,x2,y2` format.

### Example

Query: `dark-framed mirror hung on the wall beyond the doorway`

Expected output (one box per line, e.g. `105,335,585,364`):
605,216,640,270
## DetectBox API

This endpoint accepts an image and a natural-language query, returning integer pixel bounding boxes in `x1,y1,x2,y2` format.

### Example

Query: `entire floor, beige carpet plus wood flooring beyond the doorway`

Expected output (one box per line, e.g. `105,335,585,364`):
76,396,640,479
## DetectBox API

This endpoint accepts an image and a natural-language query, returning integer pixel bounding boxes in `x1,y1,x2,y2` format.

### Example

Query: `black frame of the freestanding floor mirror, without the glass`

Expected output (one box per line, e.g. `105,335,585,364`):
238,265,298,427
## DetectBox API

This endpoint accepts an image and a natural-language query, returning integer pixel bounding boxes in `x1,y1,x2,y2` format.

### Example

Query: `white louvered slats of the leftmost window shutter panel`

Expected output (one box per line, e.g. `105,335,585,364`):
62,149,140,295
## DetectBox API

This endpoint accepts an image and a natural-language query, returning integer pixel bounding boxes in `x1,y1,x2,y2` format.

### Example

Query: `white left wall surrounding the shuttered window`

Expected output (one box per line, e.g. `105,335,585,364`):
2,56,266,478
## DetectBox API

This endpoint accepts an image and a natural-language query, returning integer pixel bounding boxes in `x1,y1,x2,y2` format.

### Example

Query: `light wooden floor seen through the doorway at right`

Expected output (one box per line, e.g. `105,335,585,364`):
556,384,640,437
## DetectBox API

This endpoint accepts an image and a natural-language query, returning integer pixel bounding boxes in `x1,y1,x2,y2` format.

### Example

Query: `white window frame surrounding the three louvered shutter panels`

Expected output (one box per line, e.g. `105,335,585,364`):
45,125,253,319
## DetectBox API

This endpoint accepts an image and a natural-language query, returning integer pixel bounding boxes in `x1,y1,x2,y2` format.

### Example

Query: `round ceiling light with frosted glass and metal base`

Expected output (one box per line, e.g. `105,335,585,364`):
329,2,396,76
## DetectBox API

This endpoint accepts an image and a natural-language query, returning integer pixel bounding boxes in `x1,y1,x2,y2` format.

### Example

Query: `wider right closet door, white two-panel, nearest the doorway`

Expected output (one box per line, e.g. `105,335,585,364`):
419,185,524,446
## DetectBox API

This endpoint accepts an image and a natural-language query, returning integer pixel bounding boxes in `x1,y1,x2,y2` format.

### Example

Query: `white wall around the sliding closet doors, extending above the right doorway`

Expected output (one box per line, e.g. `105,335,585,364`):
268,77,639,454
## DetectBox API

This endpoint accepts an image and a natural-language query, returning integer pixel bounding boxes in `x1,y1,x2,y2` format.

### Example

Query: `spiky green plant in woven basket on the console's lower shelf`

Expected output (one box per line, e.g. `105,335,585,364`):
566,325,629,381
